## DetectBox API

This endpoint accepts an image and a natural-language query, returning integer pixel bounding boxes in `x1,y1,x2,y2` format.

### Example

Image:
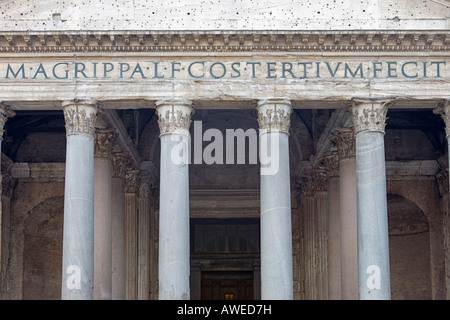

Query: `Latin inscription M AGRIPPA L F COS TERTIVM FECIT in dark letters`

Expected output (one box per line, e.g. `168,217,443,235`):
0,60,450,81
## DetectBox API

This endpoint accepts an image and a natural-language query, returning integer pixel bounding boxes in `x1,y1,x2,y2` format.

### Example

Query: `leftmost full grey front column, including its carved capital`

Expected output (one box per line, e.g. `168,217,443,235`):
61,100,97,300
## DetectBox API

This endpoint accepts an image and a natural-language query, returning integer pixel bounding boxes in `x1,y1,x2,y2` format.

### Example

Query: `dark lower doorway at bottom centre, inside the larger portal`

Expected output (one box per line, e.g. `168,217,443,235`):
201,271,253,300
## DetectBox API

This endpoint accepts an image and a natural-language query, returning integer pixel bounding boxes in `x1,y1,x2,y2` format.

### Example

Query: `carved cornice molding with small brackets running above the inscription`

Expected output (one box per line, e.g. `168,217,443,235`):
0,30,450,53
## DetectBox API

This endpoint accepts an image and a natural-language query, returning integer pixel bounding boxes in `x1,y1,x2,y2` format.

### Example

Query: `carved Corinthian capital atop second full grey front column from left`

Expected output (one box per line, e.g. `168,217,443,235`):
156,99,194,134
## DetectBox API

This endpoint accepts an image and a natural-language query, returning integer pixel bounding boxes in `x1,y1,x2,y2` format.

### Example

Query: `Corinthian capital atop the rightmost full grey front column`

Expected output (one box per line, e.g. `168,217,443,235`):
351,98,394,134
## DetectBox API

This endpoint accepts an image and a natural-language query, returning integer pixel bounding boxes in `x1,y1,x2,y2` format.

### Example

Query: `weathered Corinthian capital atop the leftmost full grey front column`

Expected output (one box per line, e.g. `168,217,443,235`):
61,99,97,135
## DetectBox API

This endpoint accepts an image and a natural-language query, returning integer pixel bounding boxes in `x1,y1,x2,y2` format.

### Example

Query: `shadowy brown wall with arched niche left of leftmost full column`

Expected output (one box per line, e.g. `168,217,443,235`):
6,165,64,299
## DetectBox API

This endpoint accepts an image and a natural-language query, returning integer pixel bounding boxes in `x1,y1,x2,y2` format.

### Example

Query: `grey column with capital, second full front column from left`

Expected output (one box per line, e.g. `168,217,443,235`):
156,99,193,300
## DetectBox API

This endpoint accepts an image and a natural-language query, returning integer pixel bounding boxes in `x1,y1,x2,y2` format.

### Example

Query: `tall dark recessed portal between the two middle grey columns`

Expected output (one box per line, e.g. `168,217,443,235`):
191,218,260,300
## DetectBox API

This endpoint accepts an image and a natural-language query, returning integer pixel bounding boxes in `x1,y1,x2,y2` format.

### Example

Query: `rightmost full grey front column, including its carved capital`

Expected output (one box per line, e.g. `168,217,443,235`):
351,98,392,300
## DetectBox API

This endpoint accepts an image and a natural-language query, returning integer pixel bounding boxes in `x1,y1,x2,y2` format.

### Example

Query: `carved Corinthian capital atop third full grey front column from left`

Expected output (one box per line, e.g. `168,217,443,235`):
257,98,292,134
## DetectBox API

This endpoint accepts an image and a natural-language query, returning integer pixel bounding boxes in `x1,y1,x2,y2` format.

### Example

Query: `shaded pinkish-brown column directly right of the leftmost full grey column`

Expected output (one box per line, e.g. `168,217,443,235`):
94,125,114,300
